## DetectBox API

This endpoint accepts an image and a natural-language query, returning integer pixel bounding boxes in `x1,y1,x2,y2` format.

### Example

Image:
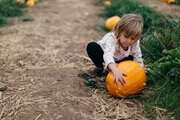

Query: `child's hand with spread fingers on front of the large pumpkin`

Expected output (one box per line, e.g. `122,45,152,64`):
113,70,127,86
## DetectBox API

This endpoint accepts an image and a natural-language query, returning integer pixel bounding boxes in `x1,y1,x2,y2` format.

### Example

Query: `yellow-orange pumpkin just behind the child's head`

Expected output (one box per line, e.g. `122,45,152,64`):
105,16,121,30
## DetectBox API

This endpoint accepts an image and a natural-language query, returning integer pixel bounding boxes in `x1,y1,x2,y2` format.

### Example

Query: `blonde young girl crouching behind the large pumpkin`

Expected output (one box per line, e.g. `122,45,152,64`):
86,14,144,85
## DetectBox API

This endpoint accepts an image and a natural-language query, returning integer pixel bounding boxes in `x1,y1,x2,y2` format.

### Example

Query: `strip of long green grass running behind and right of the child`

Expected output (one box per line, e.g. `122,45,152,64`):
96,0,180,119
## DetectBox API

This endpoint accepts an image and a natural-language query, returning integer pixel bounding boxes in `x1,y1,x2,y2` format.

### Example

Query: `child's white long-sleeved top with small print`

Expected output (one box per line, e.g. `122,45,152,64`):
97,32,144,68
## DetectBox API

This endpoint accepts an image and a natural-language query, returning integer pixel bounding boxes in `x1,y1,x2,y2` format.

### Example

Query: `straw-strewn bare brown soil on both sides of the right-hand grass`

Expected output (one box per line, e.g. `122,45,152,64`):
0,0,180,120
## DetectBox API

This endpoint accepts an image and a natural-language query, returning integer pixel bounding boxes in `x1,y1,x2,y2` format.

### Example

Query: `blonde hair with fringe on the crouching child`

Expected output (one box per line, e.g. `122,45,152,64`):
112,14,143,40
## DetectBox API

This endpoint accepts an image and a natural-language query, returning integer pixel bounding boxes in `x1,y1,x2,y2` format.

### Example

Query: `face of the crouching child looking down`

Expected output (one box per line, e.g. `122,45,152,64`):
119,32,137,50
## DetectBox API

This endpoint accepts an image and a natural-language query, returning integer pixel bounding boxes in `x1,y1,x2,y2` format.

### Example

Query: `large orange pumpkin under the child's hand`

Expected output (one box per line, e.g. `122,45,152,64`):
106,61,146,98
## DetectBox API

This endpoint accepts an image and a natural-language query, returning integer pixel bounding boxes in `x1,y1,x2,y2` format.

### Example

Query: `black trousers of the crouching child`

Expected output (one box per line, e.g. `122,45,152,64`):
86,42,133,68
